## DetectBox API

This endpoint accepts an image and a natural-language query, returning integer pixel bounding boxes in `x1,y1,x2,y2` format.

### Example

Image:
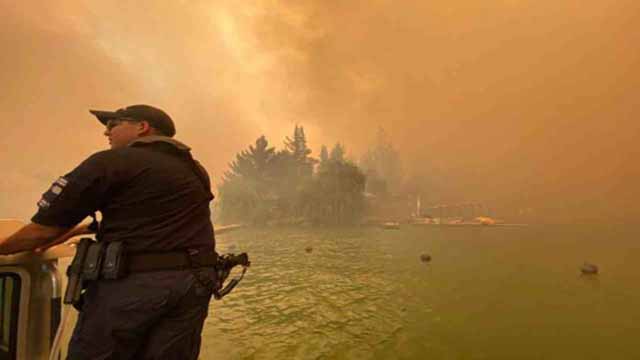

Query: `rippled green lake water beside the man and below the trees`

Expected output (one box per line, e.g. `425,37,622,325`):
201,225,640,360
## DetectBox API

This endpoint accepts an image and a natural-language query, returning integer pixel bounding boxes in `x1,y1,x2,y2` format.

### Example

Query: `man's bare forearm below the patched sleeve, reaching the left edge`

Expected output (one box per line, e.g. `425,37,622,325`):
0,223,69,255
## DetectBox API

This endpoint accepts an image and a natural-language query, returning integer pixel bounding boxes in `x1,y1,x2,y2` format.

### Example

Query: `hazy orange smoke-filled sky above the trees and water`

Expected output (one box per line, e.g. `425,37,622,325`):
0,0,640,221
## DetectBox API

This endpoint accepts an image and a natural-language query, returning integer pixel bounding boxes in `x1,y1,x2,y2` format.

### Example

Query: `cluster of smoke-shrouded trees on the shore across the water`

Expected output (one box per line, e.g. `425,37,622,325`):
219,125,366,225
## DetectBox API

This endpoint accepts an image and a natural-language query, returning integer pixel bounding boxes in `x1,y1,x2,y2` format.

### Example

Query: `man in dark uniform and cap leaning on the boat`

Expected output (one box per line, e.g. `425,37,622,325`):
0,105,216,360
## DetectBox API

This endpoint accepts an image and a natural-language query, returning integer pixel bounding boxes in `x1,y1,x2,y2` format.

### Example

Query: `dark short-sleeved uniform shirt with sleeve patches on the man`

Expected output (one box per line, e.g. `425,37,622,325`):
32,136,215,252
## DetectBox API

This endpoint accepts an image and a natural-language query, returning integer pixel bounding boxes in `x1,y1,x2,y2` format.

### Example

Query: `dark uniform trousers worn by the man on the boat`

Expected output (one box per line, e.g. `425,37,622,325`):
67,269,215,360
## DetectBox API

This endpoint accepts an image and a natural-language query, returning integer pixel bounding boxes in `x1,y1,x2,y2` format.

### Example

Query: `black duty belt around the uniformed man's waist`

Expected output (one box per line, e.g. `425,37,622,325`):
126,251,218,273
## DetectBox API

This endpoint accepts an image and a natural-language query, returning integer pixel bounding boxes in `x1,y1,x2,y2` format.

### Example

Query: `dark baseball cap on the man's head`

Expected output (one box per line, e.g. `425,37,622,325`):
89,105,176,137
